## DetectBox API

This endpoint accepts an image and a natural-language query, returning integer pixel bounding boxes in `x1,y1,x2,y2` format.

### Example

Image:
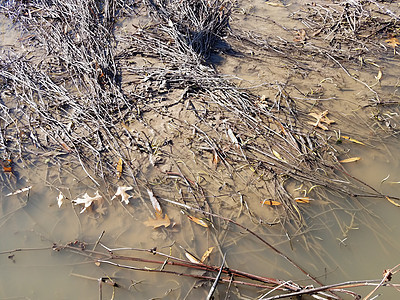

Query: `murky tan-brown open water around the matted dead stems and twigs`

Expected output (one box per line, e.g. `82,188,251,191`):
0,1,400,299
